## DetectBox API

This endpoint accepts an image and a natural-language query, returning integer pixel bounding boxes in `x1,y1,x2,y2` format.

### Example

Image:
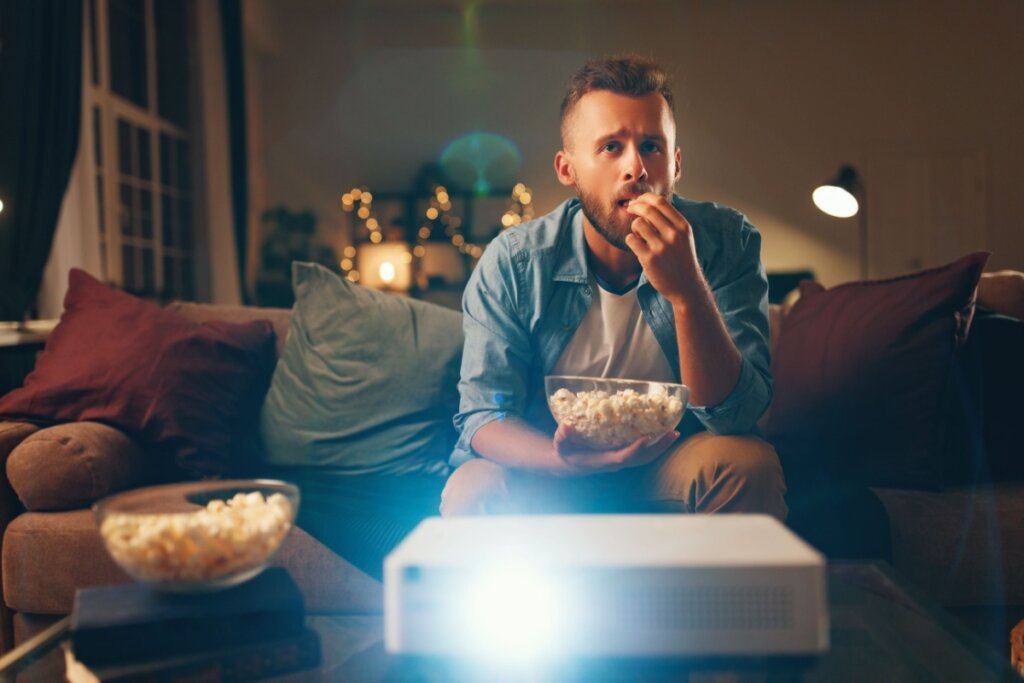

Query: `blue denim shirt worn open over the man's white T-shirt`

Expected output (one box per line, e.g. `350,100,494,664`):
450,196,772,467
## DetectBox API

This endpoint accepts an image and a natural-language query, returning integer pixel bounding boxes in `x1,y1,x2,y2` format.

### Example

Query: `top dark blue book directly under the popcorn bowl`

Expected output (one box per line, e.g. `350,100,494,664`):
71,567,304,667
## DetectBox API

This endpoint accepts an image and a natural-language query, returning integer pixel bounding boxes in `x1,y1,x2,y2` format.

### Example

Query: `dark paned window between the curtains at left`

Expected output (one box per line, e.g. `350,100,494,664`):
83,0,196,299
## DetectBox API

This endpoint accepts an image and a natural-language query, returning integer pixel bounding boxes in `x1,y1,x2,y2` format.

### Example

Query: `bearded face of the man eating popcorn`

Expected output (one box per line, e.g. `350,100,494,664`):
555,90,680,251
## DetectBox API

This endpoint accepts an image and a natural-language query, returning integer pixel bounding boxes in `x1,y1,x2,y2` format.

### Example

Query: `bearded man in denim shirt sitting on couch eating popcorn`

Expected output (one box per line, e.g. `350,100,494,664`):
440,56,786,519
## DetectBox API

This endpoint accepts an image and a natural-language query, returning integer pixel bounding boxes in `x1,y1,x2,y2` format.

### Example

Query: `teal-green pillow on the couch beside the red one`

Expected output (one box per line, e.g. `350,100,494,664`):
260,262,463,474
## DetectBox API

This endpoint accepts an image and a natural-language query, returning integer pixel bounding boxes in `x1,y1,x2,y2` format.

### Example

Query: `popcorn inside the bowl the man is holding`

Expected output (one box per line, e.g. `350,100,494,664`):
548,387,685,450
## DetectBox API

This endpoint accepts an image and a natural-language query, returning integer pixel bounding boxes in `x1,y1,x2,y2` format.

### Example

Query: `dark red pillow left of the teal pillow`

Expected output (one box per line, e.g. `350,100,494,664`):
0,269,276,475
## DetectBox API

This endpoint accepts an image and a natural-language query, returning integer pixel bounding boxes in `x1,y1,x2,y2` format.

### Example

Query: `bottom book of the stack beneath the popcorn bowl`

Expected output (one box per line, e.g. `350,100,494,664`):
65,629,321,683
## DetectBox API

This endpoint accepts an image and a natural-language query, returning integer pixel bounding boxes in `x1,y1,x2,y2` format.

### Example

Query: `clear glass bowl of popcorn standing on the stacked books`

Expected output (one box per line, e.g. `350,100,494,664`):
92,479,299,593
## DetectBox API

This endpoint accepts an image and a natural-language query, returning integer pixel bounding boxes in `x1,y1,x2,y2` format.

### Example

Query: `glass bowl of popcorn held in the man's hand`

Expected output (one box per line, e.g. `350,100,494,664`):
544,375,690,451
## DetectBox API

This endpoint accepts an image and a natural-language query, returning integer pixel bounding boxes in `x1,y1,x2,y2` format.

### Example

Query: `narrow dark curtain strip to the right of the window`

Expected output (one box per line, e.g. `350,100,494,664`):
220,0,250,303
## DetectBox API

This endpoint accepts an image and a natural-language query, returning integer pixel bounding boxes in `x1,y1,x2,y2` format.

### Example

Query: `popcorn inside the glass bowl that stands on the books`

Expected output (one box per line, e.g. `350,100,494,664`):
99,492,293,583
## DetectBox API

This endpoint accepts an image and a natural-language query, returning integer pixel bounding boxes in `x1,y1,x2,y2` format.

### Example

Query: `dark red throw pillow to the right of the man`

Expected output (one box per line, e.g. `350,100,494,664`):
765,252,988,488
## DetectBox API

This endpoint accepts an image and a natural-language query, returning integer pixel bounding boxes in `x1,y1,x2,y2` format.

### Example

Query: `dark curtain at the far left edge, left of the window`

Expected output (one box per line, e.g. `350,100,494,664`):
0,0,82,321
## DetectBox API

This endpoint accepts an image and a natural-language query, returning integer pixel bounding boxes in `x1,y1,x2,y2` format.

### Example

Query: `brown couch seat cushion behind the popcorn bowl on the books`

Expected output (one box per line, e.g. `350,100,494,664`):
3,510,382,614
